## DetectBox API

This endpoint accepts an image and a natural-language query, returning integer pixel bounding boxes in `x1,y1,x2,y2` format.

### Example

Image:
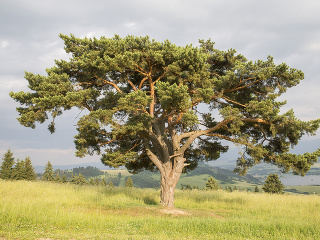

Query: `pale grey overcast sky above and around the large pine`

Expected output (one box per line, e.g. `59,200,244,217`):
0,0,320,166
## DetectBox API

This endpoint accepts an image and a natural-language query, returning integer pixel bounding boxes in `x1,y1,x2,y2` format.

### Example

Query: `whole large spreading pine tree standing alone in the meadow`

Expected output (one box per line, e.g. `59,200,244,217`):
10,35,320,206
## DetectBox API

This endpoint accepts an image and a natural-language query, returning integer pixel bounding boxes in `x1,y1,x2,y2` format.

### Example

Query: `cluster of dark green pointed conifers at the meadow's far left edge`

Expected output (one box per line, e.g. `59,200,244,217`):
0,150,37,181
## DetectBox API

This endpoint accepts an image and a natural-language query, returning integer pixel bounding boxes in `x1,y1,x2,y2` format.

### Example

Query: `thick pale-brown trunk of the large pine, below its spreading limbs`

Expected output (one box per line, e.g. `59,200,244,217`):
160,157,185,208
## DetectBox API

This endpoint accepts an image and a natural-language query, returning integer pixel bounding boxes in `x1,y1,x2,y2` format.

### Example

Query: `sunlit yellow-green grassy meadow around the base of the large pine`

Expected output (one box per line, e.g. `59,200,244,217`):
0,181,320,239
